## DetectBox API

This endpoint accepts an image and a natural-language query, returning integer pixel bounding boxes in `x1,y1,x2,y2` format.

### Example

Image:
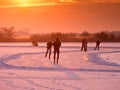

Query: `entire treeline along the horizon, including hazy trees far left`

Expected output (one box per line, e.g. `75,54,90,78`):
0,27,120,42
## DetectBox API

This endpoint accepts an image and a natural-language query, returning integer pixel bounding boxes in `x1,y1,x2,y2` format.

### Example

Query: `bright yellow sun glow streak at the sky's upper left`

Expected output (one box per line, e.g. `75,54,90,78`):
0,0,75,8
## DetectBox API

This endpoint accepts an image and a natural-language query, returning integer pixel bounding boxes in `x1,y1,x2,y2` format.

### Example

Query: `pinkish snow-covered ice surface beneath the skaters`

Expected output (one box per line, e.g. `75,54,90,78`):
0,43,120,90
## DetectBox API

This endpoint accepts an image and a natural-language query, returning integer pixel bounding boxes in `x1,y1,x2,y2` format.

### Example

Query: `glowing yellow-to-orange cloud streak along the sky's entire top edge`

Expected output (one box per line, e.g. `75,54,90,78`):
0,0,120,8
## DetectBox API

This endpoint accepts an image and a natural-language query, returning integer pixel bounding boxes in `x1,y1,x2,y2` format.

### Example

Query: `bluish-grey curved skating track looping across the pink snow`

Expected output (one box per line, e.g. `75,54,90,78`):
0,50,120,72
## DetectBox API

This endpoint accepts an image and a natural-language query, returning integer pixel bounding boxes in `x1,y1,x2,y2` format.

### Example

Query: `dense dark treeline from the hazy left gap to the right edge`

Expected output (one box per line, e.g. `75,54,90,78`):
30,31,120,42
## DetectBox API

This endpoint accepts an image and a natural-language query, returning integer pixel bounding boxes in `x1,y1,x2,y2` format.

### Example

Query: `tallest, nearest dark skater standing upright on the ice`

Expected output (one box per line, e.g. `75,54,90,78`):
53,38,61,64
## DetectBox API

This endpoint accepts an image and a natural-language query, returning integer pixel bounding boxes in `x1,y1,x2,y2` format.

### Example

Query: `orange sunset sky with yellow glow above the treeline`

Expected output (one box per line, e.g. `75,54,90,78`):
0,0,120,33
